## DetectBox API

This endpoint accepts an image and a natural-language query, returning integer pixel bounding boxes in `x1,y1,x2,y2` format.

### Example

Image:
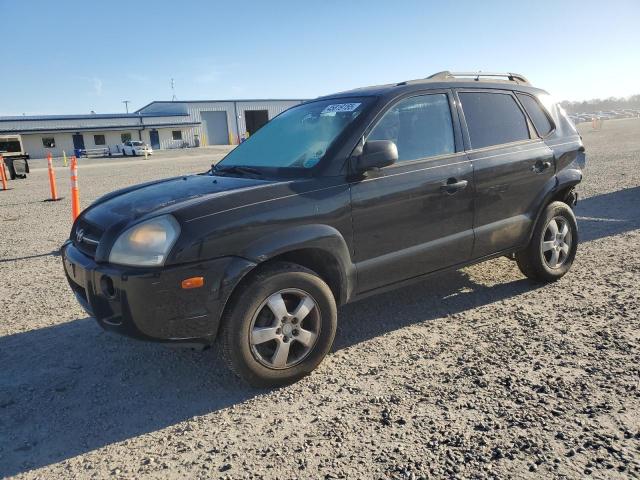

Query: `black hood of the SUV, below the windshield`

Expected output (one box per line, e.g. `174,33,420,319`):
81,175,274,230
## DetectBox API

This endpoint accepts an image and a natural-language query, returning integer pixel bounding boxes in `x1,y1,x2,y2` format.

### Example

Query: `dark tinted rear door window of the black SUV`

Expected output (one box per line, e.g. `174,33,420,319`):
458,92,531,148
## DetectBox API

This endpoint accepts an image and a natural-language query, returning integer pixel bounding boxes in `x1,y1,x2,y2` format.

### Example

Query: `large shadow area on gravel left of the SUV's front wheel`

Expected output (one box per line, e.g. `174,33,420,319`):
0,318,254,478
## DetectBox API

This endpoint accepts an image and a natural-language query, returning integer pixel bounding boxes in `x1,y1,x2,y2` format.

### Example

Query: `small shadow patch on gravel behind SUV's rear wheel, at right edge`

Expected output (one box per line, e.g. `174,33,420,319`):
576,187,640,242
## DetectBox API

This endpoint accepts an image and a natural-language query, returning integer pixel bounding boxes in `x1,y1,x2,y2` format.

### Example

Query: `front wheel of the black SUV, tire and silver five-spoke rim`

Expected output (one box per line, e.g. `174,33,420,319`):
221,262,337,388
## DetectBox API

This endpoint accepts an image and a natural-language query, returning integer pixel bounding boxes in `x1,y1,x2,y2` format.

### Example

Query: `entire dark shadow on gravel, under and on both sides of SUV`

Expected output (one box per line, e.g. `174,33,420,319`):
0,187,640,477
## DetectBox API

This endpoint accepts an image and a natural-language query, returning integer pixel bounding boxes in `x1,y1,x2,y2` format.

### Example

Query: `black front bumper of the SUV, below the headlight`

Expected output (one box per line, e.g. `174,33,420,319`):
62,242,254,343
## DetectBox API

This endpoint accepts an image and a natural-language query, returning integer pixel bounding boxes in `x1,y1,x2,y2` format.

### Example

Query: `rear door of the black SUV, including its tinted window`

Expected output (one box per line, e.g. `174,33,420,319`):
457,89,555,258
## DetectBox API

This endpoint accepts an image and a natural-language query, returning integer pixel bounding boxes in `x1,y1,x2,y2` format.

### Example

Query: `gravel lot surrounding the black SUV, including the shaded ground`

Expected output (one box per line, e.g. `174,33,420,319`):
0,119,640,479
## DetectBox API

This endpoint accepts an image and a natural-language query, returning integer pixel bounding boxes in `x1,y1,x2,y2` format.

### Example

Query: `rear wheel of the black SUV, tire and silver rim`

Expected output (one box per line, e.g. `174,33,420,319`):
516,202,578,282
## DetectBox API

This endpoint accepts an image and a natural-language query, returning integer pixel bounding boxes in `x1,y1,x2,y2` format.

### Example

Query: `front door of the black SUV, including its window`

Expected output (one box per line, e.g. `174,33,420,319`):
351,92,474,293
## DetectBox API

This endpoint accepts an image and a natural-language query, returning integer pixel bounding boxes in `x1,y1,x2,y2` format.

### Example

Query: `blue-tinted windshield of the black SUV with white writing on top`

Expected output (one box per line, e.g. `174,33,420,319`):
216,98,370,170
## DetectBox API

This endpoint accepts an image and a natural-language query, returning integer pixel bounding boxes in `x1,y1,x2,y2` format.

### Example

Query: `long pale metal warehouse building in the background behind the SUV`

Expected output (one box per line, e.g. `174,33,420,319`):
0,99,303,158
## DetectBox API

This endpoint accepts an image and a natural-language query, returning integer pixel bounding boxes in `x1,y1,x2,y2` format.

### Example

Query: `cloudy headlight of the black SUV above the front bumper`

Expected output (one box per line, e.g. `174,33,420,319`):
109,215,180,266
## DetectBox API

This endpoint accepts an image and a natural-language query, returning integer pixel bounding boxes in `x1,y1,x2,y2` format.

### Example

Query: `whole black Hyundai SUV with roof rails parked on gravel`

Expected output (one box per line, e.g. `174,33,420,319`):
62,72,585,386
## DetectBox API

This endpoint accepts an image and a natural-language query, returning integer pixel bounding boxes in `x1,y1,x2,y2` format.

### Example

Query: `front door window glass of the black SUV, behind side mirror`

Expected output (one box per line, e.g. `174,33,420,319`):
367,93,456,162
